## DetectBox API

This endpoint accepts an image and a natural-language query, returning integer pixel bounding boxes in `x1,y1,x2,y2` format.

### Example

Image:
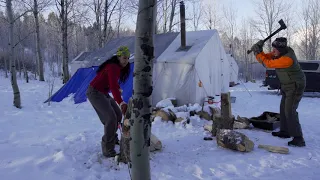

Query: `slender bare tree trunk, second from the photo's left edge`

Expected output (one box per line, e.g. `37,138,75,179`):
33,0,44,81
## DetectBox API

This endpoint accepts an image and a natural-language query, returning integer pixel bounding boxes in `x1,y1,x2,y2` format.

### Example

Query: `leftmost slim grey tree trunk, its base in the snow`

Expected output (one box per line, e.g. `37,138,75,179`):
6,0,21,108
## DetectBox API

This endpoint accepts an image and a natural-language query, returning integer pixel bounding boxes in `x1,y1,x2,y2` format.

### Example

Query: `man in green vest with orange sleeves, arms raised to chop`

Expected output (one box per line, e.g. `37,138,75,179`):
251,37,306,147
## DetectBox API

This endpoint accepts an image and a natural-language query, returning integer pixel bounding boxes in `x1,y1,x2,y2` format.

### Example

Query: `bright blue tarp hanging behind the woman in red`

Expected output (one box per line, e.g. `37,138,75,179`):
45,63,134,104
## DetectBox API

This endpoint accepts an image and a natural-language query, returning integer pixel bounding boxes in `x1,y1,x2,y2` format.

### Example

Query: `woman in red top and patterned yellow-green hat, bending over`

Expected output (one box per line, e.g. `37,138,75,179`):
86,46,130,157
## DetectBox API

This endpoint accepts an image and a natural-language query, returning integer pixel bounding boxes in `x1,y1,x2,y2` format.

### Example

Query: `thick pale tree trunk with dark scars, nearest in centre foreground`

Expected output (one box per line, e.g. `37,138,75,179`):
130,0,156,180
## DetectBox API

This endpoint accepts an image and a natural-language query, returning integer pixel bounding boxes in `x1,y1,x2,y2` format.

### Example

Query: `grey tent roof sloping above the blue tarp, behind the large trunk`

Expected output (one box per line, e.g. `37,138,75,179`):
85,32,179,66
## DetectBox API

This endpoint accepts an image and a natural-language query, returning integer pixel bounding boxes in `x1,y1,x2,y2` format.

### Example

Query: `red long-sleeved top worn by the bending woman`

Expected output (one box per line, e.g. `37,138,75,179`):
90,64,123,104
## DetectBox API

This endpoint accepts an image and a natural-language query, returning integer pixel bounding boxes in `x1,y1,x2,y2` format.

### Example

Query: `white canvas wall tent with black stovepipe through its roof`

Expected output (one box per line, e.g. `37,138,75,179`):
152,30,230,105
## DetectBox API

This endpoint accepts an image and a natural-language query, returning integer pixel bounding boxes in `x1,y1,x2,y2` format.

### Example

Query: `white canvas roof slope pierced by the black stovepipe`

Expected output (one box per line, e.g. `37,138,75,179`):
157,30,218,64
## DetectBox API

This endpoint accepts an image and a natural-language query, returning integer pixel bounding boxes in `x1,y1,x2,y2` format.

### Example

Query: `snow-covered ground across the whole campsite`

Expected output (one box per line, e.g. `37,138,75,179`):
0,77,320,180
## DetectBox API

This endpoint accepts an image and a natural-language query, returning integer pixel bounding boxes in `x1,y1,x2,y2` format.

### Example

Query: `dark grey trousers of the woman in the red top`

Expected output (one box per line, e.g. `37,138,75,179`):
86,86,122,153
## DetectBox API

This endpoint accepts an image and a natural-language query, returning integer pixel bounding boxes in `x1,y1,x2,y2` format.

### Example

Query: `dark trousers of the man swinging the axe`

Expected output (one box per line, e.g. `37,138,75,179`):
280,82,305,137
